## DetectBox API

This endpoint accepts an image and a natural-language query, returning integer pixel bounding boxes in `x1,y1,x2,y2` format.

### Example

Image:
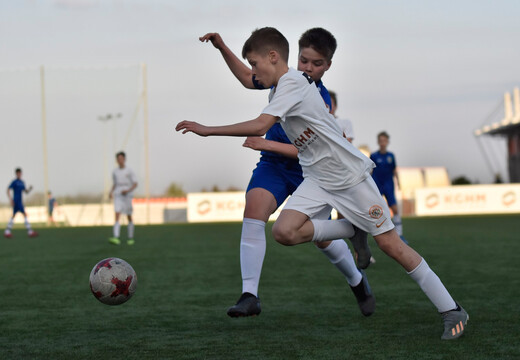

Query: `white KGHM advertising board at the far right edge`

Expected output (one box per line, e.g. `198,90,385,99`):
415,184,520,216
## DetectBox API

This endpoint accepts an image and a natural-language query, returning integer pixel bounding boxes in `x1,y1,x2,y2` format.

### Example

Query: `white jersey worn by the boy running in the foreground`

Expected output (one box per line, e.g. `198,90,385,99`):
262,68,375,190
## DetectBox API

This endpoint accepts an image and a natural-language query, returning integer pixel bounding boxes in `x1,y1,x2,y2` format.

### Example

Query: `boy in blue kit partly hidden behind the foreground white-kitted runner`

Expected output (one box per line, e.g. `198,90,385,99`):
200,28,375,317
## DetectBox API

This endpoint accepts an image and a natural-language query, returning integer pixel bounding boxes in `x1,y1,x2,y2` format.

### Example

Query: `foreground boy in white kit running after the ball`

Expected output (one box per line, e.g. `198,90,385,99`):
176,28,469,340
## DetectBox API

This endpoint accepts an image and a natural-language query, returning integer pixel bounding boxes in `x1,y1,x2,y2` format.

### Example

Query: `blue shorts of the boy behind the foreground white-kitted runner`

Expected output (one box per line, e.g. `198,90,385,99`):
247,159,303,206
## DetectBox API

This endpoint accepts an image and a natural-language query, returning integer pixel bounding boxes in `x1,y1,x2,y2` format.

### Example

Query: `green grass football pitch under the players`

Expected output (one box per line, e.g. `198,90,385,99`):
0,216,520,359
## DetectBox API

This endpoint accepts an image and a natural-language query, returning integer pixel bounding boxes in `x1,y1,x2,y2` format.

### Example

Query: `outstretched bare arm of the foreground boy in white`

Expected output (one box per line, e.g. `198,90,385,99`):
175,114,277,136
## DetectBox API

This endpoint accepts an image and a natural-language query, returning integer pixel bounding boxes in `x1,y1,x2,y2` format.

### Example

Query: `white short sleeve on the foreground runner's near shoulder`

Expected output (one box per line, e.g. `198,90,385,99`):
262,78,303,121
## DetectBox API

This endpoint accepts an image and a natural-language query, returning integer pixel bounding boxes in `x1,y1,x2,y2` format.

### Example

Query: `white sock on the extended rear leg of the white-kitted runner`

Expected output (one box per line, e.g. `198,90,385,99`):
408,259,457,312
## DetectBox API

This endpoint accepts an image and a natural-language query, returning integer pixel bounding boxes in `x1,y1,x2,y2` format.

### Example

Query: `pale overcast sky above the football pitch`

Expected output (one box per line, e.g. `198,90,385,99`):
0,0,520,195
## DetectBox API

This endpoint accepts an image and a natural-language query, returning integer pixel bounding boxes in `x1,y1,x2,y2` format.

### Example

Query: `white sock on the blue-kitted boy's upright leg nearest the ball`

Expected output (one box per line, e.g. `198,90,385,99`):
240,218,265,296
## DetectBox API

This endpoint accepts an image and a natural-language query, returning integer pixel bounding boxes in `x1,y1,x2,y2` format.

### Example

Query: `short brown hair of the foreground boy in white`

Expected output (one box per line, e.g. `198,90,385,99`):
242,27,289,62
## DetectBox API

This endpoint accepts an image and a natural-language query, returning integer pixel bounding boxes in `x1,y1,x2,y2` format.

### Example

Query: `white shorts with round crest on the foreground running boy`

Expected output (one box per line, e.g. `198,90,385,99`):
283,176,394,236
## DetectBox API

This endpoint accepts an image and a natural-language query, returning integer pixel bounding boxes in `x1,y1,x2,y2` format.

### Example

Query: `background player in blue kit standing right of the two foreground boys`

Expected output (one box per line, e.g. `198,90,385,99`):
370,131,407,242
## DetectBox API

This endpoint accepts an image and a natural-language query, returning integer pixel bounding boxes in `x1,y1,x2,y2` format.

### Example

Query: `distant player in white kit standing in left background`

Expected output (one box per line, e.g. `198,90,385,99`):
108,151,137,245
